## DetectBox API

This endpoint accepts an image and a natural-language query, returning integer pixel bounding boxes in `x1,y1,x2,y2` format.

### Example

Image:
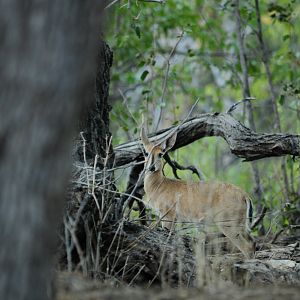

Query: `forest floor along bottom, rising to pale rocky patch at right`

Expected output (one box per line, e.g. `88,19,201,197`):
57,237,300,300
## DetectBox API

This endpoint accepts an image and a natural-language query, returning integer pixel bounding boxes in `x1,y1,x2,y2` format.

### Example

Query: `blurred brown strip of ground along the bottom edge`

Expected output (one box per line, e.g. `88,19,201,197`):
57,273,300,300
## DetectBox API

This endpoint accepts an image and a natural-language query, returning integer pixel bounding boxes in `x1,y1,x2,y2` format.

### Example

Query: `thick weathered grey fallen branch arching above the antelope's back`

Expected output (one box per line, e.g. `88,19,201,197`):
114,113,300,166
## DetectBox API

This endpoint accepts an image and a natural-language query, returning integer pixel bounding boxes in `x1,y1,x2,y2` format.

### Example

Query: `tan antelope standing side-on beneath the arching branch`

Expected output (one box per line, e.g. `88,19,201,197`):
140,126,255,258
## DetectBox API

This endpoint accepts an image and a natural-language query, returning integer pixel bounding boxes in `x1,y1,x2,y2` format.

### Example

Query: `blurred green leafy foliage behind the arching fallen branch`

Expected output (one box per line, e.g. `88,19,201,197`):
107,0,300,234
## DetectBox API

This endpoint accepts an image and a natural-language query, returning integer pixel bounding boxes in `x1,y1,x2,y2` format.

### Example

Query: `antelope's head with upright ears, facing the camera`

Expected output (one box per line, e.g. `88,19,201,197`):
141,126,177,173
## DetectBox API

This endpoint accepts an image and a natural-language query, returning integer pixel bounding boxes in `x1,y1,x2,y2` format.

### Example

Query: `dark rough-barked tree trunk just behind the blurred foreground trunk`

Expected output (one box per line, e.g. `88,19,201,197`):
60,41,121,276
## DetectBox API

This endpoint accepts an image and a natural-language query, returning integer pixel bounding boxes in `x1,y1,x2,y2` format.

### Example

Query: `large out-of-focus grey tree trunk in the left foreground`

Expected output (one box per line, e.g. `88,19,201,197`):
0,0,104,300
